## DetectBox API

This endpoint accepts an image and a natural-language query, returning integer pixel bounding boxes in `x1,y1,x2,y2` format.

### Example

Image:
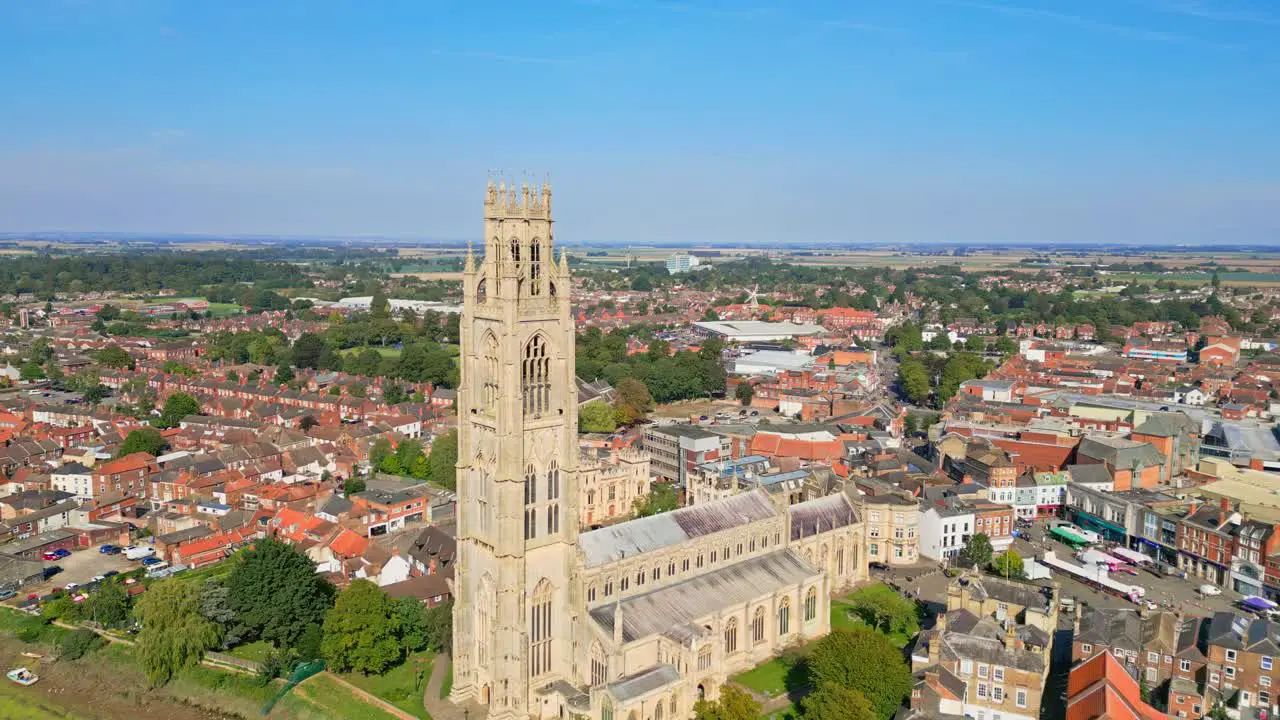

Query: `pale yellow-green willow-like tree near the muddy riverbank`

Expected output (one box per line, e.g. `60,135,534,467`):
133,580,218,685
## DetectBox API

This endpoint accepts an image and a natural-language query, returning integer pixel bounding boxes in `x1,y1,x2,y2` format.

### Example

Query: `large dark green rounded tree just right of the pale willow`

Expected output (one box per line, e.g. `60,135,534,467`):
227,538,333,647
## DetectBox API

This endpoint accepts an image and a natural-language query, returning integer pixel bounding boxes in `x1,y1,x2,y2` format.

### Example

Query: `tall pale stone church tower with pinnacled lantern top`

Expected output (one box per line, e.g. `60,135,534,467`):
452,182,579,719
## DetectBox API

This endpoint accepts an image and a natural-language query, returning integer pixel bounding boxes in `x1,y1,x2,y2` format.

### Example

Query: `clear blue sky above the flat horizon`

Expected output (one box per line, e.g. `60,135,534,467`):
0,0,1280,243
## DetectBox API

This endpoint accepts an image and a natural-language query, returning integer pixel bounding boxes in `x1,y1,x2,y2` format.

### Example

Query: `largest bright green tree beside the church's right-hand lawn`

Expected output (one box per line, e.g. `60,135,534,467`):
805,628,911,720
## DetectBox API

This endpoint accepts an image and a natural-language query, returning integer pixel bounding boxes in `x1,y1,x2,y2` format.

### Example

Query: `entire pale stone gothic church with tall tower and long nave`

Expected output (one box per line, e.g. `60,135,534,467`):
452,183,867,720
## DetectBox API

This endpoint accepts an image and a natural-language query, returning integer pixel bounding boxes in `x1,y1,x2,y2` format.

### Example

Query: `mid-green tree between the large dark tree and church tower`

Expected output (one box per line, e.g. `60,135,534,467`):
320,580,403,675
